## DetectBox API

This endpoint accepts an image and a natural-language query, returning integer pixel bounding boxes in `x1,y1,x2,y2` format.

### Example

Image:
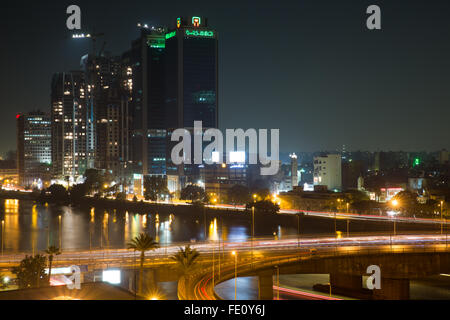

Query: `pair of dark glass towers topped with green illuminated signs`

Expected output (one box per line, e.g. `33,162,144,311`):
122,17,218,182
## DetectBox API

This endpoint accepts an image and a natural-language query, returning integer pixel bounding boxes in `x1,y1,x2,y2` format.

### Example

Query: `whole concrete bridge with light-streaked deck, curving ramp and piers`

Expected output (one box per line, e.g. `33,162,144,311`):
0,234,450,300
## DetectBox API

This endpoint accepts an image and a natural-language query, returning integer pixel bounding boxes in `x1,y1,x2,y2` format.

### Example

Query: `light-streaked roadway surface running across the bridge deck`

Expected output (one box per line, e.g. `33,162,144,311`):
0,234,450,267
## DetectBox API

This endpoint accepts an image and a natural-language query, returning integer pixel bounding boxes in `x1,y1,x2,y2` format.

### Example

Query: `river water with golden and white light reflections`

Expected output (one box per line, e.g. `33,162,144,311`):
0,199,295,253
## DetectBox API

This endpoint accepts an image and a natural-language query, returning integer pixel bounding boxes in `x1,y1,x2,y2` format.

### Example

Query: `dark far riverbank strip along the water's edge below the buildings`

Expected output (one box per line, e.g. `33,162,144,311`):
0,190,439,236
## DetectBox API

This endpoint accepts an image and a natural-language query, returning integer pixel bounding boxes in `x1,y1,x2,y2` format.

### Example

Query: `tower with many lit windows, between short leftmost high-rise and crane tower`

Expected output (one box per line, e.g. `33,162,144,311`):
51,71,94,182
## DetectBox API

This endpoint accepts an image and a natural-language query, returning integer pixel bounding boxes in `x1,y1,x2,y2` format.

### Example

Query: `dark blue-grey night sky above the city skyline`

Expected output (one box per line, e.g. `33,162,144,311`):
0,0,450,153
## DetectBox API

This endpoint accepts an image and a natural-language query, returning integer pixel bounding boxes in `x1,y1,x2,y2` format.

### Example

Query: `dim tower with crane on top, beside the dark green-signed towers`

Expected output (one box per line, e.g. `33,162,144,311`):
81,54,129,178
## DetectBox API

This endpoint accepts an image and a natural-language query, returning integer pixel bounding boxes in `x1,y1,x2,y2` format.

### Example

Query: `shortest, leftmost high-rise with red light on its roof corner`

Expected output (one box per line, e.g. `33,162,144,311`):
16,111,52,187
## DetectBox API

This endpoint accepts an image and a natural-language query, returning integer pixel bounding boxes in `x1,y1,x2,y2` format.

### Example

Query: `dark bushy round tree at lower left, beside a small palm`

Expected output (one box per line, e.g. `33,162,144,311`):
12,254,48,289
